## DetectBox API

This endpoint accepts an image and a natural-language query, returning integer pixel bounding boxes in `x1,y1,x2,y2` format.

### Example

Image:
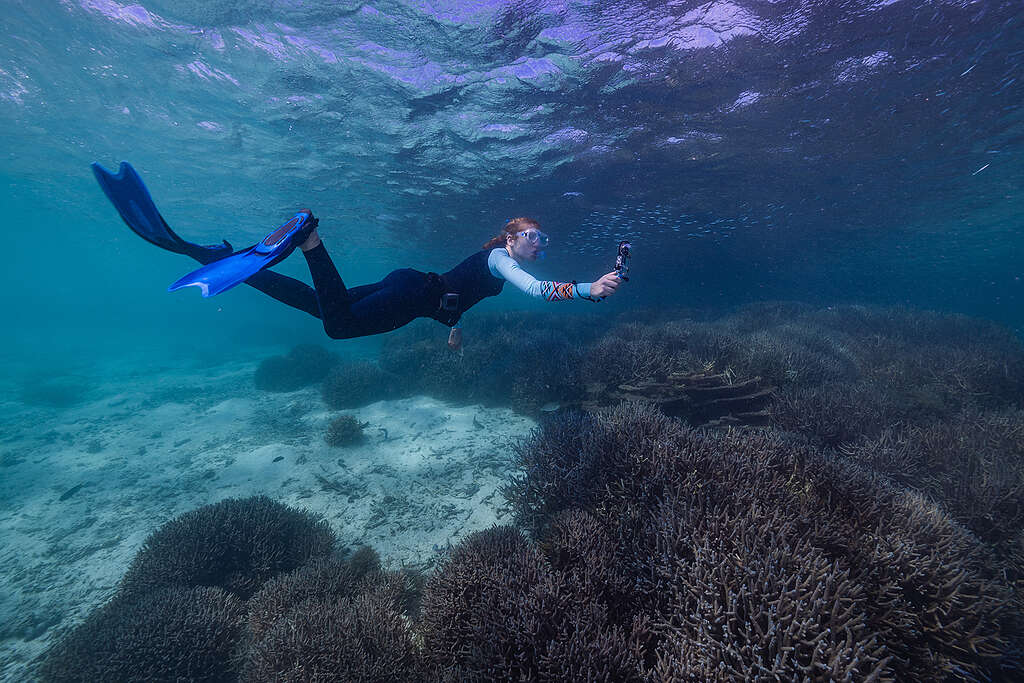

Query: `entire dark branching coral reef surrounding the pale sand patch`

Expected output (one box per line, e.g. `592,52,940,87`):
37,304,1024,681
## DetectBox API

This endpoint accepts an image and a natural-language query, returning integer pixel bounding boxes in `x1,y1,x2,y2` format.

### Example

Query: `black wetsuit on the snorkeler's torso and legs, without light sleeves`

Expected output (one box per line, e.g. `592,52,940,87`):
246,244,505,339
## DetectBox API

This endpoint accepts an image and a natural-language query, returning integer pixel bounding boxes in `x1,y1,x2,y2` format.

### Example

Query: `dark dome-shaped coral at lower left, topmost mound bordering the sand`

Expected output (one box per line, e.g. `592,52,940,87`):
120,496,335,599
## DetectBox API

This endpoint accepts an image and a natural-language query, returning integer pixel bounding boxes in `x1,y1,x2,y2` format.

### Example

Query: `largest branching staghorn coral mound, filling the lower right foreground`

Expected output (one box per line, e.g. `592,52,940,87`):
493,405,1019,680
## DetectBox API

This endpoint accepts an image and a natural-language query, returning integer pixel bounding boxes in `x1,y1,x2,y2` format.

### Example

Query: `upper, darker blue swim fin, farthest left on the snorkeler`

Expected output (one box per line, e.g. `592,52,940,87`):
92,161,231,263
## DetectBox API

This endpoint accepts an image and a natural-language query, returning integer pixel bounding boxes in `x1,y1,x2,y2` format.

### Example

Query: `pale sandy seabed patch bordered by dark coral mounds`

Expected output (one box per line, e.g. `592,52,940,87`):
0,356,536,681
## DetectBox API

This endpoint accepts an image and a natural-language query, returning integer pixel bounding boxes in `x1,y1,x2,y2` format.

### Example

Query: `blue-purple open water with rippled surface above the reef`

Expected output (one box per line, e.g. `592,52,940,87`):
0,0,1024,358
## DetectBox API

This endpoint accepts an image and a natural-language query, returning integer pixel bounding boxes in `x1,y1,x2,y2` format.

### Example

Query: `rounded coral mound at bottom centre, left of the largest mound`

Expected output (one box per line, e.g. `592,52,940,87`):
419,527,640,681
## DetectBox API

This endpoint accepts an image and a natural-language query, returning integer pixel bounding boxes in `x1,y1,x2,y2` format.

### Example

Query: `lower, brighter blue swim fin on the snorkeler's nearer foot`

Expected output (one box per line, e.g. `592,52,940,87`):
167,209,318,297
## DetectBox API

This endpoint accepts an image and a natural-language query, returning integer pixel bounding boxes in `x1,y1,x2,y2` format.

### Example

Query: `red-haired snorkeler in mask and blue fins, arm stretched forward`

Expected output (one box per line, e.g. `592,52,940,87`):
92,162,622,349
